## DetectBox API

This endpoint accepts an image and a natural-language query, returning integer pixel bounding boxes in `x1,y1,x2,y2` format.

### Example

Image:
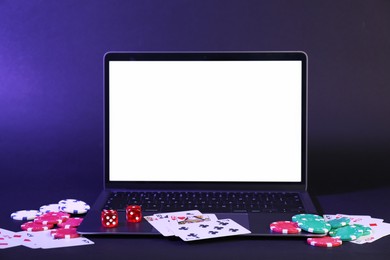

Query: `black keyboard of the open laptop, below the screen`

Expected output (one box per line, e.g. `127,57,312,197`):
103,192,304,213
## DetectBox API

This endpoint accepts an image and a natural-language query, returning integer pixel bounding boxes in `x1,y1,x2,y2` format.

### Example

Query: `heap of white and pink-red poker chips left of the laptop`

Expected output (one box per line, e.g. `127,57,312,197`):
11,199,90,239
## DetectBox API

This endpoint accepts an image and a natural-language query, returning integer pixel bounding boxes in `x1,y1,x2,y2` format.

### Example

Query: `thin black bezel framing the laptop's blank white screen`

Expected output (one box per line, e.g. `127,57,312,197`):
103,51,308,191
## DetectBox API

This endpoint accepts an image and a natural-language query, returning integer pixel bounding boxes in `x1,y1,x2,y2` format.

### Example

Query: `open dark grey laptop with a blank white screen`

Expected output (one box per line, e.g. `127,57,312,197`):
78,52,318,236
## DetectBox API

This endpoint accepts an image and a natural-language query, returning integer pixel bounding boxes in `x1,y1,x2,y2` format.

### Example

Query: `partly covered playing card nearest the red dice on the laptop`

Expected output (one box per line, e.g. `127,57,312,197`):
144,210,202,236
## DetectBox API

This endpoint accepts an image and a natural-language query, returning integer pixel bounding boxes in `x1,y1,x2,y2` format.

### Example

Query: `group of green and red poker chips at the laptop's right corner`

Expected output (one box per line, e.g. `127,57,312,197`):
270,214,372,247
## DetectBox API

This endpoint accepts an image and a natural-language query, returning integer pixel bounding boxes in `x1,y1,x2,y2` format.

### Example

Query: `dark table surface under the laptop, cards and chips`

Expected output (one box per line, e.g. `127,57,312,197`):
0,187,390,260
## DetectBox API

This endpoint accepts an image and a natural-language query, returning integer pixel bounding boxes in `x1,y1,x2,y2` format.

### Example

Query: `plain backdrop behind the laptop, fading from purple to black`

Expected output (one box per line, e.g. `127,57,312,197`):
0,0,390,200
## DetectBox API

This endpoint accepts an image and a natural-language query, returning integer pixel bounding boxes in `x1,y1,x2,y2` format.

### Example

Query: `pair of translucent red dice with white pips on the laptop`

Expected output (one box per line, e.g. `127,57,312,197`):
101,205,142,228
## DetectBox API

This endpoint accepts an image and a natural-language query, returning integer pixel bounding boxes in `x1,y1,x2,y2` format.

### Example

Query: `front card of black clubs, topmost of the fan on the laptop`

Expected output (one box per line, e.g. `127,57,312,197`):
175,219,251,241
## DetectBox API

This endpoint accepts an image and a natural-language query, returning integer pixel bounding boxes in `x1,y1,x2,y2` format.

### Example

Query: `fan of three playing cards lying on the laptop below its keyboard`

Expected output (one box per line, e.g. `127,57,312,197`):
144,210,251,241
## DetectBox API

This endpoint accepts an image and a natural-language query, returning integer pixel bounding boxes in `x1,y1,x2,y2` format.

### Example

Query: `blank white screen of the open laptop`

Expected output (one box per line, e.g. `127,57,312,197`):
106,52,306,182
